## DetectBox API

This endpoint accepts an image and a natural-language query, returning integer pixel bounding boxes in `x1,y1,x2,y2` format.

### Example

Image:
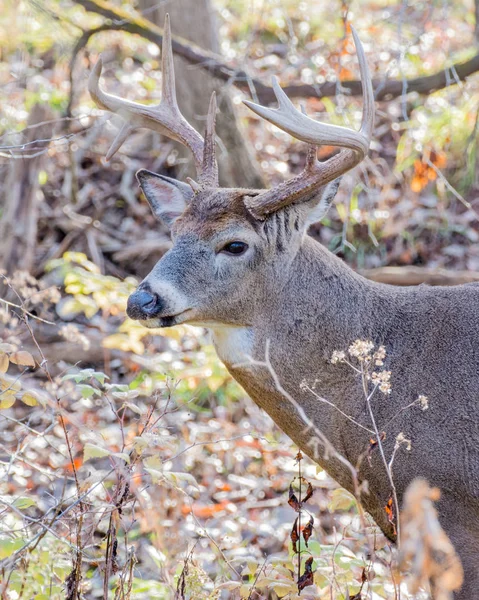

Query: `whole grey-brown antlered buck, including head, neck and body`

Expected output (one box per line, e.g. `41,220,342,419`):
89,19,479,599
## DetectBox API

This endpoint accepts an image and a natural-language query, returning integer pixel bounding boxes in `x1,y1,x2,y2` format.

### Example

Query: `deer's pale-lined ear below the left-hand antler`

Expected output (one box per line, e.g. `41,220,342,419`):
136,169,193,228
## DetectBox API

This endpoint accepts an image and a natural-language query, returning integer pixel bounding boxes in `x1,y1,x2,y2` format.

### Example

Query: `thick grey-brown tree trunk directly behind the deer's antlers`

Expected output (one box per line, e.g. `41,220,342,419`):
139,0,263,188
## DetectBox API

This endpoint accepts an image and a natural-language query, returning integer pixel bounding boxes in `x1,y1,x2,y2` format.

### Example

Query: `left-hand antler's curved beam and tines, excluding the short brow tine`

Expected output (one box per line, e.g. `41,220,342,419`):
88,15,203,173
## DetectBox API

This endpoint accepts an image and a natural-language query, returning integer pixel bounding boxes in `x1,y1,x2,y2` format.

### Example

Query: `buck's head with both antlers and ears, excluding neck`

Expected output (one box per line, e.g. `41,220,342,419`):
89,16,374,327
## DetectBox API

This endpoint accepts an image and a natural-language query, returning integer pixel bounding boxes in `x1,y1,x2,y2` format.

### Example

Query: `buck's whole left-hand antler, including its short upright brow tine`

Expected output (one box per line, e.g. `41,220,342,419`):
88,14,218,187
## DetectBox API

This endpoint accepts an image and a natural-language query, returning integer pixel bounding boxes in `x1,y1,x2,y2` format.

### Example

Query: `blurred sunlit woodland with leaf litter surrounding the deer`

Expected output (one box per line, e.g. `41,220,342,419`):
0,0,479,600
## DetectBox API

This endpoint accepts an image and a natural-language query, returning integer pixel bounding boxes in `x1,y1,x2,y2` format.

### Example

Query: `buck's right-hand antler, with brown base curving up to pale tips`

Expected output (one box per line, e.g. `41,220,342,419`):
244,27,374,218
